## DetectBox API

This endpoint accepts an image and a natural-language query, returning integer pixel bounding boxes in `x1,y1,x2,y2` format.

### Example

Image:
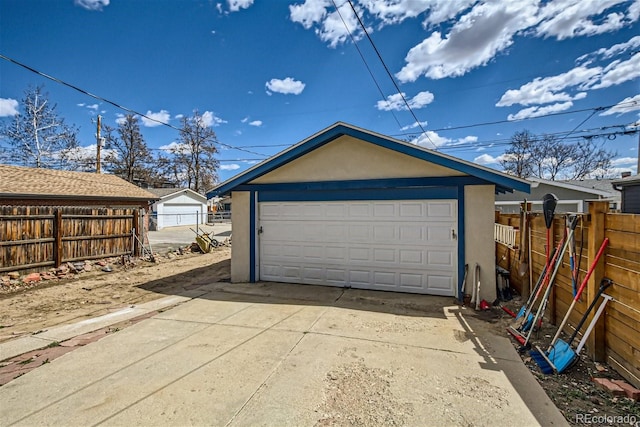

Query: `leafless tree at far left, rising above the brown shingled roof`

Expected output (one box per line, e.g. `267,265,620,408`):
0,86,78,168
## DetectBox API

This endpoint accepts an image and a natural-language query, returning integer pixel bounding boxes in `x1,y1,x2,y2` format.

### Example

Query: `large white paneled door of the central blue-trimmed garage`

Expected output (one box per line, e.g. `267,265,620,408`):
258,200,457,296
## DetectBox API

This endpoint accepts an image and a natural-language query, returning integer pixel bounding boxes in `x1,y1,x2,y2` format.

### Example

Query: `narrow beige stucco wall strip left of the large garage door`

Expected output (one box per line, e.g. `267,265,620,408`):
231,191,252,282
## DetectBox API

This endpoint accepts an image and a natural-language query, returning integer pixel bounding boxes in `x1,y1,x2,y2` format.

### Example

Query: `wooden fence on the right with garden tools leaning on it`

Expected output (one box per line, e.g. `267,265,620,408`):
496,201,640,387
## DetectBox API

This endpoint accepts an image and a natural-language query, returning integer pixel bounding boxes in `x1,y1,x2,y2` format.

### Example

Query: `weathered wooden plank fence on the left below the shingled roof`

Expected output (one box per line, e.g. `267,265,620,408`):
0,206,139,272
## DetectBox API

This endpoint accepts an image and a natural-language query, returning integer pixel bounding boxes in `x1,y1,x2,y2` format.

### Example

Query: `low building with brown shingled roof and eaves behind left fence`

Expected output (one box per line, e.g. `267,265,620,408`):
0,165,156,209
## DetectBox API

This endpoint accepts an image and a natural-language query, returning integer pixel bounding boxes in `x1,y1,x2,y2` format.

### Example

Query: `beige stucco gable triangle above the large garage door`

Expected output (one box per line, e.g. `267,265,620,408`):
250,136,464,185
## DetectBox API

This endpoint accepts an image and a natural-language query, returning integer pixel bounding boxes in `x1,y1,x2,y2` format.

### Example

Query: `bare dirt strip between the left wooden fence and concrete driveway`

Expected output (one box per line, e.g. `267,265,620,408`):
0,247,231,342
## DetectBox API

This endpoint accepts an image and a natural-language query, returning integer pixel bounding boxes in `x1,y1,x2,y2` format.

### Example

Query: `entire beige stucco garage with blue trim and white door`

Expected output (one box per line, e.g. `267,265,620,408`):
207,123,529,301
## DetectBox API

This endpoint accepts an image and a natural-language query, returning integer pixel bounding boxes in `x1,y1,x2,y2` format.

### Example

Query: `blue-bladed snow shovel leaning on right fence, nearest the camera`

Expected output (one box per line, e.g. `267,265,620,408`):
530,277,613,374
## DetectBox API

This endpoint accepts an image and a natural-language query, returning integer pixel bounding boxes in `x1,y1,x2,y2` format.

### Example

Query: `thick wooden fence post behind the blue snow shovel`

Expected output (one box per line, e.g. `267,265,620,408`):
586,201,609,362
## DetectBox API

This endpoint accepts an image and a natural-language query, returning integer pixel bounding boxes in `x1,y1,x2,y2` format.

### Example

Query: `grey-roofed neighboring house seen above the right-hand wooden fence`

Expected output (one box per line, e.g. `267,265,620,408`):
496,178,620,213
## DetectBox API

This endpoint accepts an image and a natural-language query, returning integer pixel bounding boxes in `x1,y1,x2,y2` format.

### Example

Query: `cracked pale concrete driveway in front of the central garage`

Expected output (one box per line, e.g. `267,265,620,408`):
0,283,567,426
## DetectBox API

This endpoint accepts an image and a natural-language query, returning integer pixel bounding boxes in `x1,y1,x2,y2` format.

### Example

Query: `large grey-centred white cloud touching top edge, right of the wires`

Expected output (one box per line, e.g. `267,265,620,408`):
396,0,537,82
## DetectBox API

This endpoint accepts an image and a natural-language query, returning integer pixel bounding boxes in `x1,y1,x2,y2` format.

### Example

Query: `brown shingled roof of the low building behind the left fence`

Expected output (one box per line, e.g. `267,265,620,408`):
0,165,157,201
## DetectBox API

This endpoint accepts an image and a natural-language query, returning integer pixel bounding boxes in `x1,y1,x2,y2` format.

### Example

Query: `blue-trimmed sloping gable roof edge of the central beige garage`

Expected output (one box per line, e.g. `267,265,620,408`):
207,122,530,199
